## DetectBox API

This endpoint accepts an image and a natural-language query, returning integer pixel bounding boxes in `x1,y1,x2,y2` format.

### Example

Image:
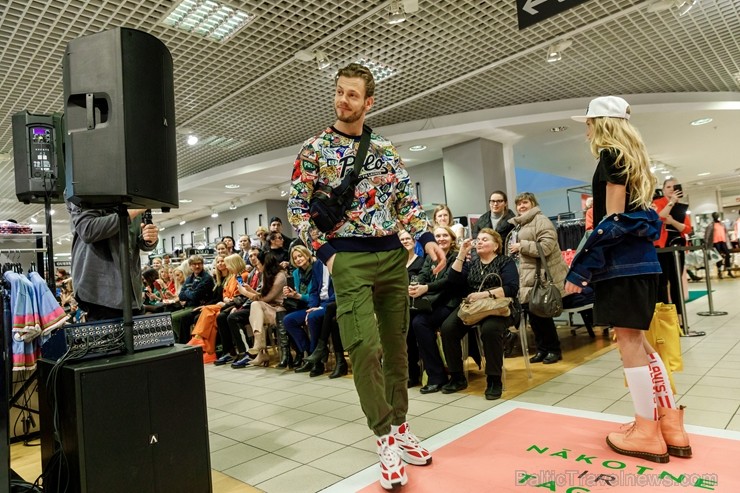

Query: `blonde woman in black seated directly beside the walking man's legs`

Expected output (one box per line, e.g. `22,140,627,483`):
409,226,461,394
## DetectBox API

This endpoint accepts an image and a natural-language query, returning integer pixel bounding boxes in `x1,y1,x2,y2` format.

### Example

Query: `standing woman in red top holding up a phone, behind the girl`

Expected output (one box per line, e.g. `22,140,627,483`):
653,178,691,317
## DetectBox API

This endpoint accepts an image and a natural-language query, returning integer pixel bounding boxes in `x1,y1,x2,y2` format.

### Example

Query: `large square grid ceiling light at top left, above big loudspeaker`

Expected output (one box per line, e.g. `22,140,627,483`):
162,0,255,42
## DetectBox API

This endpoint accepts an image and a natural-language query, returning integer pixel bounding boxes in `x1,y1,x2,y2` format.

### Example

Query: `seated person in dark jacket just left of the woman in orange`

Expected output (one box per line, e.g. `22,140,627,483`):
172,255,215,344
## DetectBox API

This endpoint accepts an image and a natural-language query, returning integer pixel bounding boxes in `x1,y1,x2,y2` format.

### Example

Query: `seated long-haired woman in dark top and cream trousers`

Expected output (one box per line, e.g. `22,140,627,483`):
246,252,288,366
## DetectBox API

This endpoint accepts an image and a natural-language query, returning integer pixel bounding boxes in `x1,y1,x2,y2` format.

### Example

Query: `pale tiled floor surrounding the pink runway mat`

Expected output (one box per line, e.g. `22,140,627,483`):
206,280,740,493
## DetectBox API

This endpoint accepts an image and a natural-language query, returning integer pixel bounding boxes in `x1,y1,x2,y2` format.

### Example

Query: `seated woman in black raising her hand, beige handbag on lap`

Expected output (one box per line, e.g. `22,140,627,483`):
441,228,519,400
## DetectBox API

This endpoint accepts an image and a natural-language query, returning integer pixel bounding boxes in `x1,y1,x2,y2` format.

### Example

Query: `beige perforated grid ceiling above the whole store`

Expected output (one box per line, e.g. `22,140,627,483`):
0,0,740,226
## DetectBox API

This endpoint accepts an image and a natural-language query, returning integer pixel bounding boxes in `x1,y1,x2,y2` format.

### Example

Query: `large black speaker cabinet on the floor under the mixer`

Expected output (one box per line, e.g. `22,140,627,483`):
38,346,212,493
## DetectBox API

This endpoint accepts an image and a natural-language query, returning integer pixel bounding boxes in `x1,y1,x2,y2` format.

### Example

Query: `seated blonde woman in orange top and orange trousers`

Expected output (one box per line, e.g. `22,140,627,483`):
188,254,246,363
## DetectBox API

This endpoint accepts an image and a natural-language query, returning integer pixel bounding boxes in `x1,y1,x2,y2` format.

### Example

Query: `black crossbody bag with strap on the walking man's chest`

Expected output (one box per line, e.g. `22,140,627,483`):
308,125,372,233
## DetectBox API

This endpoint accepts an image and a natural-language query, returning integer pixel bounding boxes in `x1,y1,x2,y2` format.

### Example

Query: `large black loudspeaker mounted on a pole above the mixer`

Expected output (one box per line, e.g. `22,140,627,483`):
64,28,178,209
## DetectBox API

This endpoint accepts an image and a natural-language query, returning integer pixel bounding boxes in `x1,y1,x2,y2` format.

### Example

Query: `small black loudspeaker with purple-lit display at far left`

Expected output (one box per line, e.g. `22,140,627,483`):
13,111,65,204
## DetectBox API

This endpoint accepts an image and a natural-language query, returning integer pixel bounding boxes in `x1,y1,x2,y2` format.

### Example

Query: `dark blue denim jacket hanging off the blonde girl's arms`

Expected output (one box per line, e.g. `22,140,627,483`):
566,209,662,286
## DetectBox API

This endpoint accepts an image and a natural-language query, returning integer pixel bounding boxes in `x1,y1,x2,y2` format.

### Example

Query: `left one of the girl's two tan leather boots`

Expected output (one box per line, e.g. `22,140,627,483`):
606,416,669,464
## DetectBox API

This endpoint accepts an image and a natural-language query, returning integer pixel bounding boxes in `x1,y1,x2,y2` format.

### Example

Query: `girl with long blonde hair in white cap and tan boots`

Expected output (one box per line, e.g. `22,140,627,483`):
565,96,691,463
